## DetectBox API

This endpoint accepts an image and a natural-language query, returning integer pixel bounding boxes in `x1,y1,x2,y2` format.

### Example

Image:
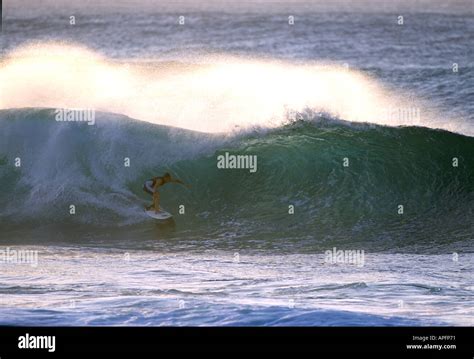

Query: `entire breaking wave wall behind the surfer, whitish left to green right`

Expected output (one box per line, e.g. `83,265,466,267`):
0,110,474,251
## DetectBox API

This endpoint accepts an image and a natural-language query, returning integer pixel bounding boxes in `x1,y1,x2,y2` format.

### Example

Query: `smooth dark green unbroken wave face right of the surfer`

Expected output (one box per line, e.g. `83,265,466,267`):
164,123,474,249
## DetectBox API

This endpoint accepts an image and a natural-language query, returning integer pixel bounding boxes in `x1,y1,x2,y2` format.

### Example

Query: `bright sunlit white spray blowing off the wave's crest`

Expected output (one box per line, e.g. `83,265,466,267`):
0,43,474,135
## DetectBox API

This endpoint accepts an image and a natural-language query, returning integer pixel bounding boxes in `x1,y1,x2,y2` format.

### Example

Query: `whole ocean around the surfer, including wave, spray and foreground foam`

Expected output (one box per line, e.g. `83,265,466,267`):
0,1,474,326
